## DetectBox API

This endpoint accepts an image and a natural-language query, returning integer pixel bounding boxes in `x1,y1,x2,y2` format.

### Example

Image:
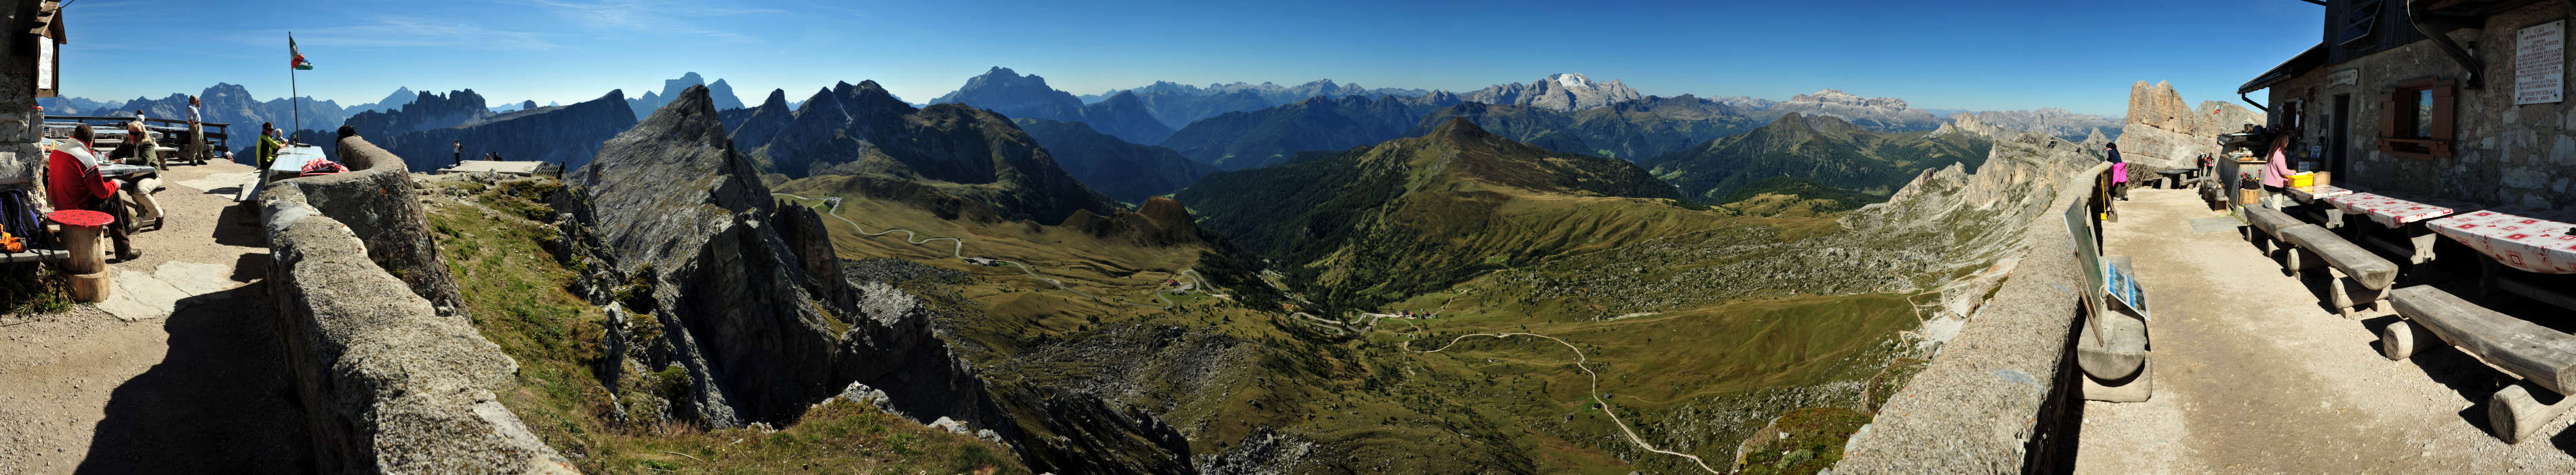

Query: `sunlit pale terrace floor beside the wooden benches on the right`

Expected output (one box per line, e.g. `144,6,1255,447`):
2074,189,2576,472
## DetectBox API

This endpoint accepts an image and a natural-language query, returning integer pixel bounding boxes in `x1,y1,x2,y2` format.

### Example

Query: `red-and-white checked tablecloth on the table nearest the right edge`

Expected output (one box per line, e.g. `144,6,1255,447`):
2424,212,2576,273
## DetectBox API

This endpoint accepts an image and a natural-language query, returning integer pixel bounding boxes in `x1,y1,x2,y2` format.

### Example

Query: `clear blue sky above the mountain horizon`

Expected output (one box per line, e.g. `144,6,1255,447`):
62,0,2324,113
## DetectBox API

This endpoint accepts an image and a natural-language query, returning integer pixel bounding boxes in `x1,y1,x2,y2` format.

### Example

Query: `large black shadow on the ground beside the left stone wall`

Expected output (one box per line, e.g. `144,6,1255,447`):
77,284,312,472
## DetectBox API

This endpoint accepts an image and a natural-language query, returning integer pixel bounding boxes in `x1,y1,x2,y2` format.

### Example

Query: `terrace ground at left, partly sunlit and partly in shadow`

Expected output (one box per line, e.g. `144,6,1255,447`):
0,163,312,472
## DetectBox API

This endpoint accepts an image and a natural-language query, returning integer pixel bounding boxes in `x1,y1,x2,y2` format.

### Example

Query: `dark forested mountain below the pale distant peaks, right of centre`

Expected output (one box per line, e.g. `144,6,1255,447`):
1638,111,1994,204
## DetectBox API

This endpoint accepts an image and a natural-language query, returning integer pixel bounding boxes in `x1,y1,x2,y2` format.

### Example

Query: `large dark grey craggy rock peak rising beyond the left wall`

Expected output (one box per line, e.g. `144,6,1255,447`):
561,88,997,426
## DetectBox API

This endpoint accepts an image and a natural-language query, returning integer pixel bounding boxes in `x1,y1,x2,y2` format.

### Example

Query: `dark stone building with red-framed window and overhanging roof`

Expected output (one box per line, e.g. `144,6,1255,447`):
2238,0,2576,209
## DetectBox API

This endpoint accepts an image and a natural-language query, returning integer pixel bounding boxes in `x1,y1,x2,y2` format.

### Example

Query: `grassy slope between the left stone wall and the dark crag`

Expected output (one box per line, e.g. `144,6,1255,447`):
428,183,1028,472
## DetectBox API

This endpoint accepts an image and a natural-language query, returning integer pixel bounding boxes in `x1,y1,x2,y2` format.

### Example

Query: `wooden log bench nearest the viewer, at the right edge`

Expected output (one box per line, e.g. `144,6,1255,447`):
2380,286,2576,444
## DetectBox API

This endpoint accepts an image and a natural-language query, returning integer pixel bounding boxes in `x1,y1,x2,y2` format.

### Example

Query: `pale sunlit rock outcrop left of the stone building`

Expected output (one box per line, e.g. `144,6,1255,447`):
2120,80,2264,173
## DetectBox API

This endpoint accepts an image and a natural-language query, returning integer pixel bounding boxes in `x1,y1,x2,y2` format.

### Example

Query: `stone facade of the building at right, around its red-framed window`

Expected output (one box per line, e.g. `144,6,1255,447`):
2270,3,2576,209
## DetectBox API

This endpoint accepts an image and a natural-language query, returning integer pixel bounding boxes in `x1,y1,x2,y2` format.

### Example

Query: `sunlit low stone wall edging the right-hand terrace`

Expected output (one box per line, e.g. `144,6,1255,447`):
1834,163,2110,472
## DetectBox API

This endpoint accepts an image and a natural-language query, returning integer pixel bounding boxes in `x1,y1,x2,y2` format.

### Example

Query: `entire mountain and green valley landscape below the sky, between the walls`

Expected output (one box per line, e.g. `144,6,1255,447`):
85,67,2118,472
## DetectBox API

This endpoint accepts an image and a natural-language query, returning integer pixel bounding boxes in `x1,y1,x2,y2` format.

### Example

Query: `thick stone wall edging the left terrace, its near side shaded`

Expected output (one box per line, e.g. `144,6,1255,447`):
260,137,574,472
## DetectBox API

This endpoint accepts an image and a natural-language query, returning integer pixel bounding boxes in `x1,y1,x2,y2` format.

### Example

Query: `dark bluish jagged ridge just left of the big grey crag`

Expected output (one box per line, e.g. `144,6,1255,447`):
381,90,637,170
